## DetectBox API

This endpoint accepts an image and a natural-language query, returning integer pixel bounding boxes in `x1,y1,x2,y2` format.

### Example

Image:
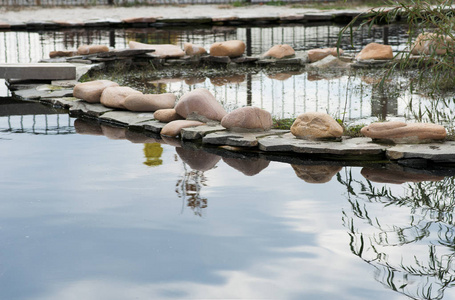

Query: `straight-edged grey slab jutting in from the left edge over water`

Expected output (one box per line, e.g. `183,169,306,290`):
0,63,76,80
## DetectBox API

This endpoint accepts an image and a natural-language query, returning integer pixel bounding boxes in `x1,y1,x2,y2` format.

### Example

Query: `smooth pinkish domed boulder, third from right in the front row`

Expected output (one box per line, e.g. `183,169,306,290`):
221,106,273,132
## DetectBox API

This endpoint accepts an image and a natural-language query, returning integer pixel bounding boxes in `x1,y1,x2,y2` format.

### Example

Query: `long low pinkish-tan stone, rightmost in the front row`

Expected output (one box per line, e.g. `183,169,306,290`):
360,121,447,144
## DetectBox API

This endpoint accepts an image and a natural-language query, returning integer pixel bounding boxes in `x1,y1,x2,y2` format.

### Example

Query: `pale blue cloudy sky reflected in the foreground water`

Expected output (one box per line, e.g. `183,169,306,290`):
0,118,453,299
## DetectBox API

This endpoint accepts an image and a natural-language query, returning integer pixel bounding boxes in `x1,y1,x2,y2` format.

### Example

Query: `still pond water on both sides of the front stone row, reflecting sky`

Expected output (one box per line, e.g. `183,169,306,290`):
0,25,455,299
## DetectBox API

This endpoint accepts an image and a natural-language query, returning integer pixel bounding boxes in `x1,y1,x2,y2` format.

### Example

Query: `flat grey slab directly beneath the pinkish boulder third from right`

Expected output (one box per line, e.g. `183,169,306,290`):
202,130,289,147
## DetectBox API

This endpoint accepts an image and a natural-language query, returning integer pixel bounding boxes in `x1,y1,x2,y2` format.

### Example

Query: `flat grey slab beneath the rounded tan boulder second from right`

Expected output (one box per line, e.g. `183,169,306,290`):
259,133,388,155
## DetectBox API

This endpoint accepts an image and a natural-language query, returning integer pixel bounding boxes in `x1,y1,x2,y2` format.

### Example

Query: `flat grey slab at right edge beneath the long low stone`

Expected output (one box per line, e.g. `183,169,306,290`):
386,142,455,162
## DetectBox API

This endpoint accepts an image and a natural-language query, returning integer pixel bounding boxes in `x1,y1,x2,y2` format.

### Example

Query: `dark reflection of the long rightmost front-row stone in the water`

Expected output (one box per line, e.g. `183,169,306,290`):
360,168,444,184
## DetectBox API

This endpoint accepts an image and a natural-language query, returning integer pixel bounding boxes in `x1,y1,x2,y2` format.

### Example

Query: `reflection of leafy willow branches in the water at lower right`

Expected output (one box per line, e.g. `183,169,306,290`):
337,166,455,299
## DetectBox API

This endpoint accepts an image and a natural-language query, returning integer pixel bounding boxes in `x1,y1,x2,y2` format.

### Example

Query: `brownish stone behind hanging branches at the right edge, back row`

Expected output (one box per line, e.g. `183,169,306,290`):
411,33,454,55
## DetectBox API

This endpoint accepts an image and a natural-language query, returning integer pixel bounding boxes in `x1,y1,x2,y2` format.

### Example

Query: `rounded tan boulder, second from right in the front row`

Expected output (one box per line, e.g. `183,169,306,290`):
291,112,343,140
